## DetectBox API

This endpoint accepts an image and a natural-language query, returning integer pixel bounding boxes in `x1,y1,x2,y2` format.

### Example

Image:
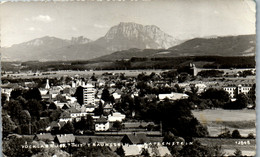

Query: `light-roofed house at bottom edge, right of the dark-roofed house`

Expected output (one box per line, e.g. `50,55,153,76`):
147,146,172,157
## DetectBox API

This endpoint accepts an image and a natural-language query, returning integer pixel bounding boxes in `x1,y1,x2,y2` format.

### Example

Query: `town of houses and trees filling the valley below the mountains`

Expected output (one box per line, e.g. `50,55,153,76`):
1,63,256,156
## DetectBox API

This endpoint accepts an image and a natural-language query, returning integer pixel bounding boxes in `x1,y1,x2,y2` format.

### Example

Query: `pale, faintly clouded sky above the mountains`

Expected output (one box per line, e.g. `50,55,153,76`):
0,0,256,47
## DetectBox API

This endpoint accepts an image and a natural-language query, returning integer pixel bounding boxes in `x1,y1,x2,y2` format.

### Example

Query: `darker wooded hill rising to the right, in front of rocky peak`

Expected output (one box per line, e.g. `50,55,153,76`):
94,35,256,61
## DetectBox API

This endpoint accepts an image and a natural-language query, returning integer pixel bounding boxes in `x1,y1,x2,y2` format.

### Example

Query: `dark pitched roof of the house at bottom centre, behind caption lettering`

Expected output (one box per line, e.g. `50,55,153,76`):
121,133,148,145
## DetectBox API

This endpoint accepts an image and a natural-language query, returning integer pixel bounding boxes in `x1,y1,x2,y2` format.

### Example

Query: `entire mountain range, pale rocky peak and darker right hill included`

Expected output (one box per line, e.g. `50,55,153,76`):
1,22,256,61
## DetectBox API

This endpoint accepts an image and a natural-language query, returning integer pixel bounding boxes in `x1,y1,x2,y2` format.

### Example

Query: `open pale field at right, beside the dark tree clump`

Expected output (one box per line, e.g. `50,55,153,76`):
192,109,256,137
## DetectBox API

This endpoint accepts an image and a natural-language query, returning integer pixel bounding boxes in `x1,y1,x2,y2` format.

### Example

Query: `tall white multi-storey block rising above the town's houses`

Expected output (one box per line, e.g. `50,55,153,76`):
83,84,95,105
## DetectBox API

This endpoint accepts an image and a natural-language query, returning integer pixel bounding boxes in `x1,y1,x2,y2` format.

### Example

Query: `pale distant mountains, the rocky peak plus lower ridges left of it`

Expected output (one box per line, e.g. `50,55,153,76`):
1,22,180,61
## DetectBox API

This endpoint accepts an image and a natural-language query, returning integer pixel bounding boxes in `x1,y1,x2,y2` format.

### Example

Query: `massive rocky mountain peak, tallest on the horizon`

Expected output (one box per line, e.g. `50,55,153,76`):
101,22,178,50
